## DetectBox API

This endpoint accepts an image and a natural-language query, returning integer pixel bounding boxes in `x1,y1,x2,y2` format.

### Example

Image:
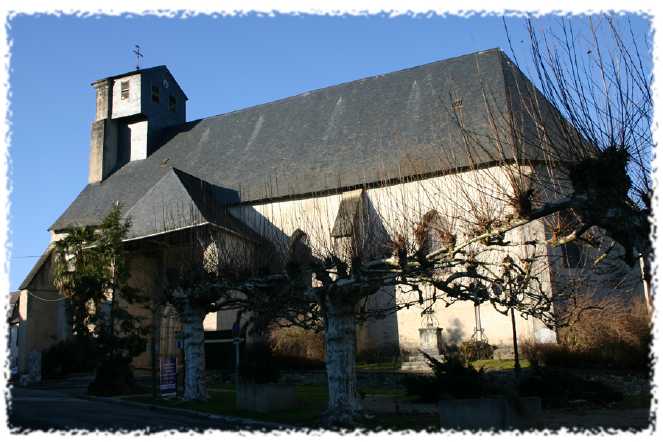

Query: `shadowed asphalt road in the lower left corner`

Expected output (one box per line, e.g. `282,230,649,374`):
8,387,274,434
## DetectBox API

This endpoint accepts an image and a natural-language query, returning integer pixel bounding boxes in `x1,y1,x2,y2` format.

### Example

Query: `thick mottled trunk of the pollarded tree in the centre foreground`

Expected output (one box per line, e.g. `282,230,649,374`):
323,299,361,425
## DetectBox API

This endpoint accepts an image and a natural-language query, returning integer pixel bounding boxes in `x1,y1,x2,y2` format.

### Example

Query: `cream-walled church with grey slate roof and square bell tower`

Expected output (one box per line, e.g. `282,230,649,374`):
19,49,640,370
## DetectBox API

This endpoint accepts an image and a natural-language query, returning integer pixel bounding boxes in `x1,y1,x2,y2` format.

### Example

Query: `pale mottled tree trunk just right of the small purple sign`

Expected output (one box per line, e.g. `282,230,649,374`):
182,302,207,401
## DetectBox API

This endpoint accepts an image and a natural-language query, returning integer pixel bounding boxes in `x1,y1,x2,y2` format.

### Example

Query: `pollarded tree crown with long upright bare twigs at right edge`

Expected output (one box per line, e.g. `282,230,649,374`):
494,15,655,272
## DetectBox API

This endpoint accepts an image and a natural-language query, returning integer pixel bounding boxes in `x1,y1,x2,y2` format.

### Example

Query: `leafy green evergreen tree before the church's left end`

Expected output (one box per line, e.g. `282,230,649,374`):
49,205,147,395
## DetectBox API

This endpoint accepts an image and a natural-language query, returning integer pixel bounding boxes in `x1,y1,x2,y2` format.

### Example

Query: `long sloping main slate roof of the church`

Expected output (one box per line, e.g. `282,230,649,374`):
51,49,540,233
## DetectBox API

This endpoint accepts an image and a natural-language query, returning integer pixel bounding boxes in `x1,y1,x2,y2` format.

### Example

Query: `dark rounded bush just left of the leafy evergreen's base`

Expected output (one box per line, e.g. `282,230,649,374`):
41,336,99,379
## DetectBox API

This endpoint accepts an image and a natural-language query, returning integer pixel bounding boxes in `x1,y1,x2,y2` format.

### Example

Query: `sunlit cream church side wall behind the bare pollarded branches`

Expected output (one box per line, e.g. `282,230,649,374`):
233,167,550,354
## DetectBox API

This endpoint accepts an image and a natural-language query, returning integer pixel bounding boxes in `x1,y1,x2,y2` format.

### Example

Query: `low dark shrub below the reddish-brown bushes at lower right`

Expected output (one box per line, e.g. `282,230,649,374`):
518,368,623,408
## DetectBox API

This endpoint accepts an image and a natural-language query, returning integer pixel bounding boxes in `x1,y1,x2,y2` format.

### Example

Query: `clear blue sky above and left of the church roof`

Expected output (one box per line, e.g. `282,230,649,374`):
9,12,649,290
